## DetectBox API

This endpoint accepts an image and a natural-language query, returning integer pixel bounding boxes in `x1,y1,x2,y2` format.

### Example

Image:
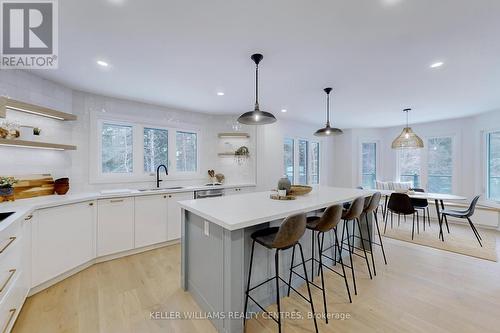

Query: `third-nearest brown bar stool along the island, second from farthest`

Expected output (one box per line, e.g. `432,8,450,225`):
340,197,373,295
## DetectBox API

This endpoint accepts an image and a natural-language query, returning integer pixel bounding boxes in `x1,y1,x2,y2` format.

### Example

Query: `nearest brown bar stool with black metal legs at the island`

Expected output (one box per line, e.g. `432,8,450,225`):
243,214,318,333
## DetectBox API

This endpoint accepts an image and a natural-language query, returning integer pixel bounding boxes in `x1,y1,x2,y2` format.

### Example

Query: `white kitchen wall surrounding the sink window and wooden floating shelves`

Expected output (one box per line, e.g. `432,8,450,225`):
0,71,332,192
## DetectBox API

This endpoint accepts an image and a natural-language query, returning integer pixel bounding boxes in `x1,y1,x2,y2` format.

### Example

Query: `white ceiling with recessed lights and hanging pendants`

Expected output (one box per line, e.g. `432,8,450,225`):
32,0,500,128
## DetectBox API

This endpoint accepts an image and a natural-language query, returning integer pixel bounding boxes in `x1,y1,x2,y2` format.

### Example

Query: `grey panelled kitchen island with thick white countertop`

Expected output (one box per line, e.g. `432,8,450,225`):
179,187,370,333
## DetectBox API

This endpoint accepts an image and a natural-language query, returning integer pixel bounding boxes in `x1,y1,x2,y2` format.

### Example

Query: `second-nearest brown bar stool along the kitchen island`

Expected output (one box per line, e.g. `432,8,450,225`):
288,205,352,324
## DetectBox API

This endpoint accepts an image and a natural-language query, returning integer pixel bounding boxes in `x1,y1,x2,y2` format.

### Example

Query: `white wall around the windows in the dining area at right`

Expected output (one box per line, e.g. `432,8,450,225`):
330,110,500,202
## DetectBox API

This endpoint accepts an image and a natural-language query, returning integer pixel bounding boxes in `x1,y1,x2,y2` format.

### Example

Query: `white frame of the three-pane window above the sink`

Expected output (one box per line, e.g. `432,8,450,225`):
88,112,201,184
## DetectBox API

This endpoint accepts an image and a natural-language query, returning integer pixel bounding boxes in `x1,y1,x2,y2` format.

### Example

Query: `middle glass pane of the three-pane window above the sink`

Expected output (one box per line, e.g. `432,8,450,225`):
144,127,168,173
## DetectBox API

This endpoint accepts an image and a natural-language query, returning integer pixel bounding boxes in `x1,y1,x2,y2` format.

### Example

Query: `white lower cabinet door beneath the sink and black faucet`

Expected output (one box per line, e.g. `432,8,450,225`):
135,194,168,248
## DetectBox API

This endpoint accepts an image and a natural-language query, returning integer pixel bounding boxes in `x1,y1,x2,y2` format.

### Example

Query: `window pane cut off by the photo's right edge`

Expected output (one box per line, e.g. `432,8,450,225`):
486,132,500,201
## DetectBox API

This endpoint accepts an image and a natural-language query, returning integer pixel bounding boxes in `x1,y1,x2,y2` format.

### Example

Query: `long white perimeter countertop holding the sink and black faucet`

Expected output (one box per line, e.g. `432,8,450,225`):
0,184,256,231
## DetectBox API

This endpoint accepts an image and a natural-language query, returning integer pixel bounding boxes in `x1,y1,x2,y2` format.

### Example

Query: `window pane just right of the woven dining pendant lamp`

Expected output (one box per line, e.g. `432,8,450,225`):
427,137,453,193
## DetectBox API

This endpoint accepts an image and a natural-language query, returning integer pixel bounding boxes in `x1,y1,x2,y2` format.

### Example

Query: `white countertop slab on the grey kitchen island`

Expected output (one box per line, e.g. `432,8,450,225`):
179,187,371,231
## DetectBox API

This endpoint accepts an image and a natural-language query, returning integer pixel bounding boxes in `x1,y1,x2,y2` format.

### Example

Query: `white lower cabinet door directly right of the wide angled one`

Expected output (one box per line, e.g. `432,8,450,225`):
97,197,135,257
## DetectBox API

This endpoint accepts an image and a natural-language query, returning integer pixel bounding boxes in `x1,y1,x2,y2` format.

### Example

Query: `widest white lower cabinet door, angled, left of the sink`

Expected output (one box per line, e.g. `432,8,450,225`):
31,201,96,286
